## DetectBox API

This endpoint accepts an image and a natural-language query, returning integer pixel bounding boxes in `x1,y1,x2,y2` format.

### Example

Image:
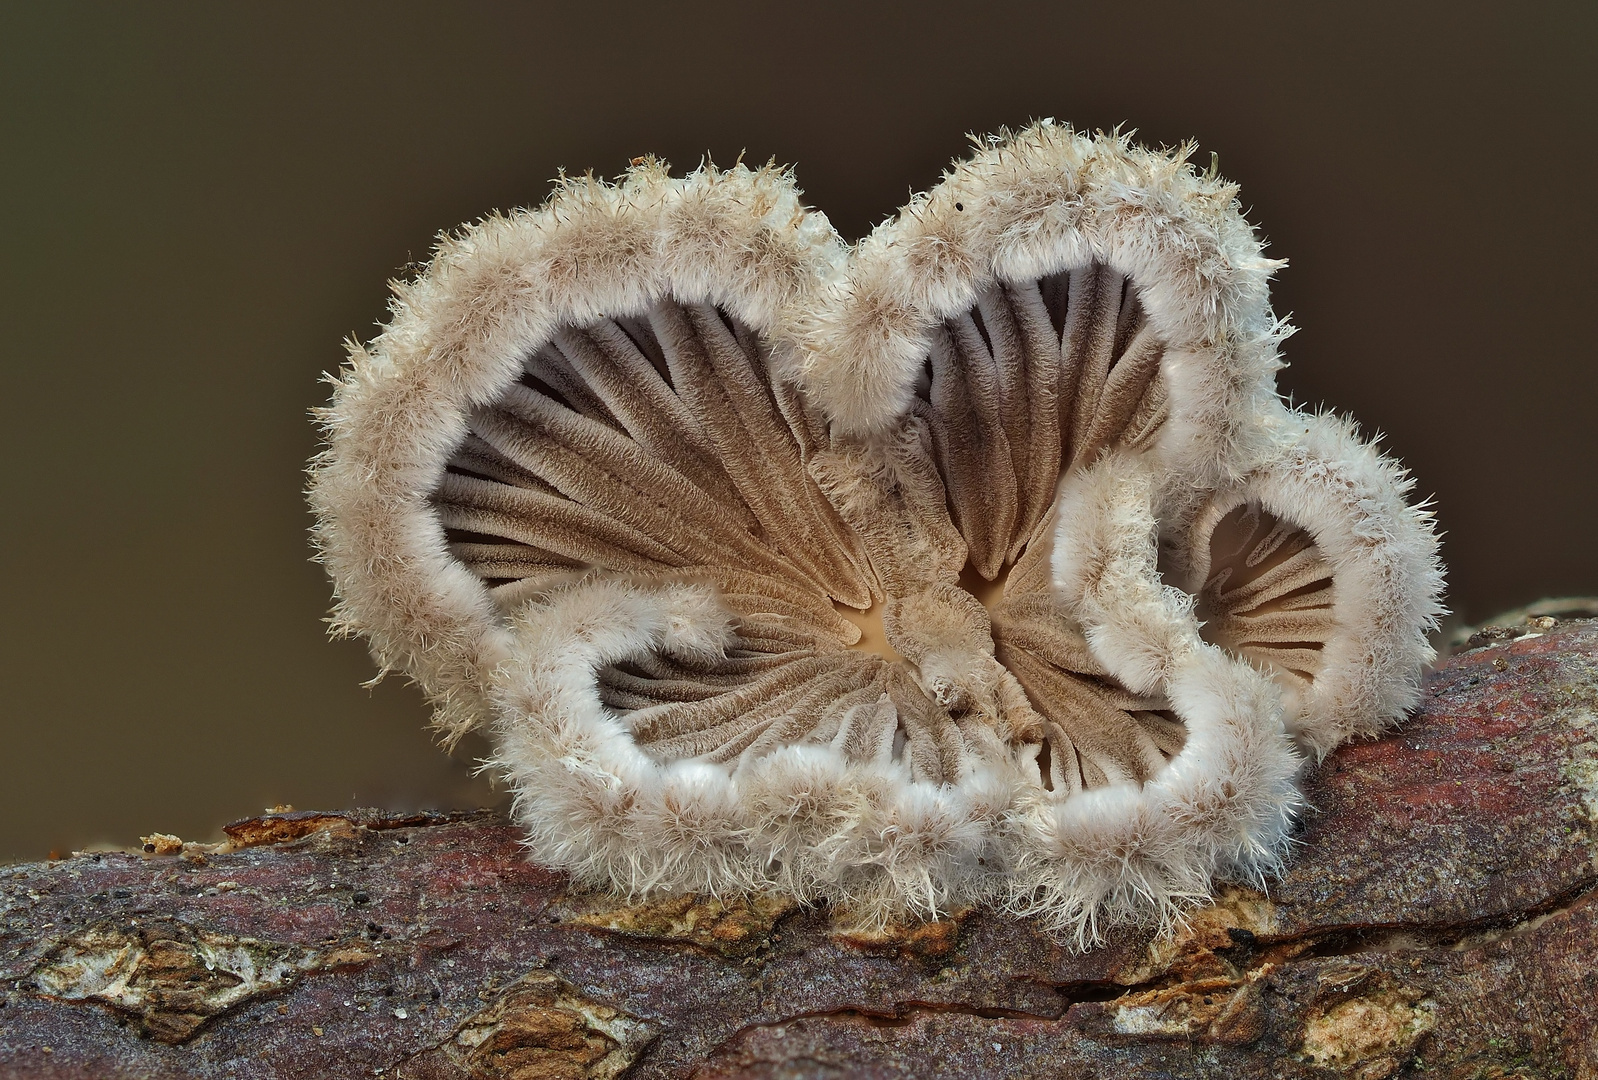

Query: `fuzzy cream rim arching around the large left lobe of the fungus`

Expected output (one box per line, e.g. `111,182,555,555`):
310,161,844,735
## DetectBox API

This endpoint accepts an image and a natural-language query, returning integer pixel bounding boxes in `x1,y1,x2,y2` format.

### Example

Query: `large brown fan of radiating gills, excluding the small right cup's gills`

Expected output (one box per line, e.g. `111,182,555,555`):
433,264,1183,792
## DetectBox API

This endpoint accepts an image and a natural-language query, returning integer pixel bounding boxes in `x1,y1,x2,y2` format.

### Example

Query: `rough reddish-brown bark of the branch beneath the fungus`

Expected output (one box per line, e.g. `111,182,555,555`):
0,620,1598,1080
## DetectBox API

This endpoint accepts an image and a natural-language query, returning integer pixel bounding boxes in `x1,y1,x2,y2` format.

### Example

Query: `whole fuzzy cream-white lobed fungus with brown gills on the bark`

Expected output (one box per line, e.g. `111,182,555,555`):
310,121,1441,941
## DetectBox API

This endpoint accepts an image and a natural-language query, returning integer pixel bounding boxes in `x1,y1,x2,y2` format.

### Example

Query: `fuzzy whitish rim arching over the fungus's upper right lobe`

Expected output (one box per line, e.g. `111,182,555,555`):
801,121,1286,486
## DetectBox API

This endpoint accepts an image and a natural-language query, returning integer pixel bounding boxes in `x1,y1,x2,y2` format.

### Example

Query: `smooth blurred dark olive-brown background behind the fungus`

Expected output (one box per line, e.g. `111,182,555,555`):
0,2,1598,858
